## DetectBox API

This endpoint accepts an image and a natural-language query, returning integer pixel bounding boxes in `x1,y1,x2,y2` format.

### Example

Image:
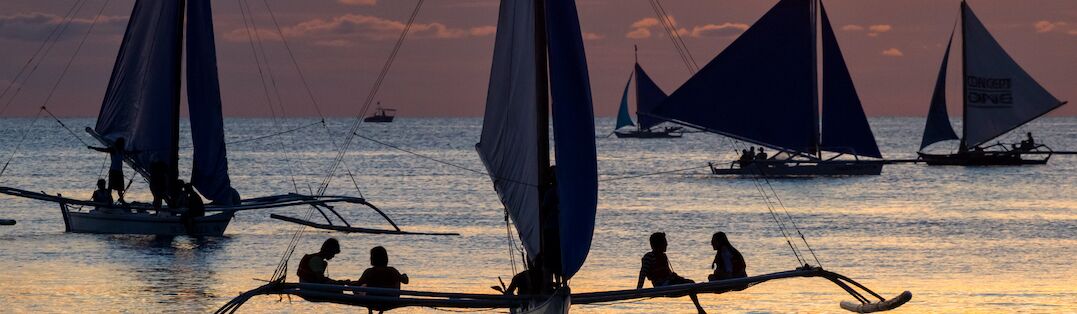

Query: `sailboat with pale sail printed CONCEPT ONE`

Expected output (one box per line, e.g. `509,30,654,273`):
918,1,1066,166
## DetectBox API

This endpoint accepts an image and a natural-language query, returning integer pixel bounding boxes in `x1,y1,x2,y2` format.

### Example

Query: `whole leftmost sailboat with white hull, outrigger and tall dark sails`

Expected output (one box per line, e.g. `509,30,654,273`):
0,0,411,236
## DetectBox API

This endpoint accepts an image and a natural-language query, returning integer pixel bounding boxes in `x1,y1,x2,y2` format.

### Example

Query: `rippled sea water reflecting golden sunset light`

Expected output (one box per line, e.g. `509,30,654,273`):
0,118,1077,313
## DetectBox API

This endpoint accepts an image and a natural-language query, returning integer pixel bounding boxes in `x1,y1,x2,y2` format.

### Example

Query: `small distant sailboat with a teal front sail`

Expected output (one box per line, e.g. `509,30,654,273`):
614,47,683,139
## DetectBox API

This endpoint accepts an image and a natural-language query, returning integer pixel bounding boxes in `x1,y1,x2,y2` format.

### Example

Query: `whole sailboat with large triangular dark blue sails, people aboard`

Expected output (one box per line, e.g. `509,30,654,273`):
646,0,883,176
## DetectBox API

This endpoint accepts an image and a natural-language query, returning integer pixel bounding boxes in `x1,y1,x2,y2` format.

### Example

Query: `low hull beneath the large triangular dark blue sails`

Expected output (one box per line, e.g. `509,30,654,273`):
711,160,883,177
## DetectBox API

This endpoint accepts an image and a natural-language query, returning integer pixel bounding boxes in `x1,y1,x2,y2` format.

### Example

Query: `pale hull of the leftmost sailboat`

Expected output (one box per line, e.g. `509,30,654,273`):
60,204,234,237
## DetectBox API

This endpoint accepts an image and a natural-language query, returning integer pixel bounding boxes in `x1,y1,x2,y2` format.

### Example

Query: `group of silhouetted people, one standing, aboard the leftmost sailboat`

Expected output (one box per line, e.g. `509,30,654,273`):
88,138,206,220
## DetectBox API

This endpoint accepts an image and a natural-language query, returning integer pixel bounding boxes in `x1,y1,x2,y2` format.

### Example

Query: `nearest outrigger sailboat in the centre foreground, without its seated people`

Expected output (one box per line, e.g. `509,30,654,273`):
216,0,912,313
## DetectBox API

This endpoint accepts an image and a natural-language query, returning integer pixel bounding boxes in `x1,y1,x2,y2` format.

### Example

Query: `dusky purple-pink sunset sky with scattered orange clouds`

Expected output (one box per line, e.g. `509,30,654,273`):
0,0,1077,116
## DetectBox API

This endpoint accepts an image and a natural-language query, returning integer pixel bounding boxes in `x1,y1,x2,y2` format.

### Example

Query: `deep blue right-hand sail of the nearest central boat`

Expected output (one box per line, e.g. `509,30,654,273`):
546,0,599,279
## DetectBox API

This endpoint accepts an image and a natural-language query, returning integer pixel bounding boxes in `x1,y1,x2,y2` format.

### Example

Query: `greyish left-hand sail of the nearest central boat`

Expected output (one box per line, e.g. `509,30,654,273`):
475,0,538,257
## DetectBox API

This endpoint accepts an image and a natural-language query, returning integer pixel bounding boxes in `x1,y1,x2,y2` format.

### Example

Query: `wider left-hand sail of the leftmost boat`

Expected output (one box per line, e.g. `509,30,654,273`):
94,0,183,180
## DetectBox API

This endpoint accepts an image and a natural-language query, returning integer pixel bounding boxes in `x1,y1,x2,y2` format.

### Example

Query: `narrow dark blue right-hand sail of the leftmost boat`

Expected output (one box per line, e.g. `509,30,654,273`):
187,0,239,204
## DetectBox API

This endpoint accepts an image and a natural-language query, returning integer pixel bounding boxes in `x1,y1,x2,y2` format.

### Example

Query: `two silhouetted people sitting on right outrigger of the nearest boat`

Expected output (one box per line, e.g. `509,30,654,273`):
635,231,747,313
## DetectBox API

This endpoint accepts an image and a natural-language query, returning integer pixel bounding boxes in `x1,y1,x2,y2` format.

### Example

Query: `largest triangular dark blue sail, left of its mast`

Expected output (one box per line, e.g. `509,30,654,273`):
641,0,817,152
